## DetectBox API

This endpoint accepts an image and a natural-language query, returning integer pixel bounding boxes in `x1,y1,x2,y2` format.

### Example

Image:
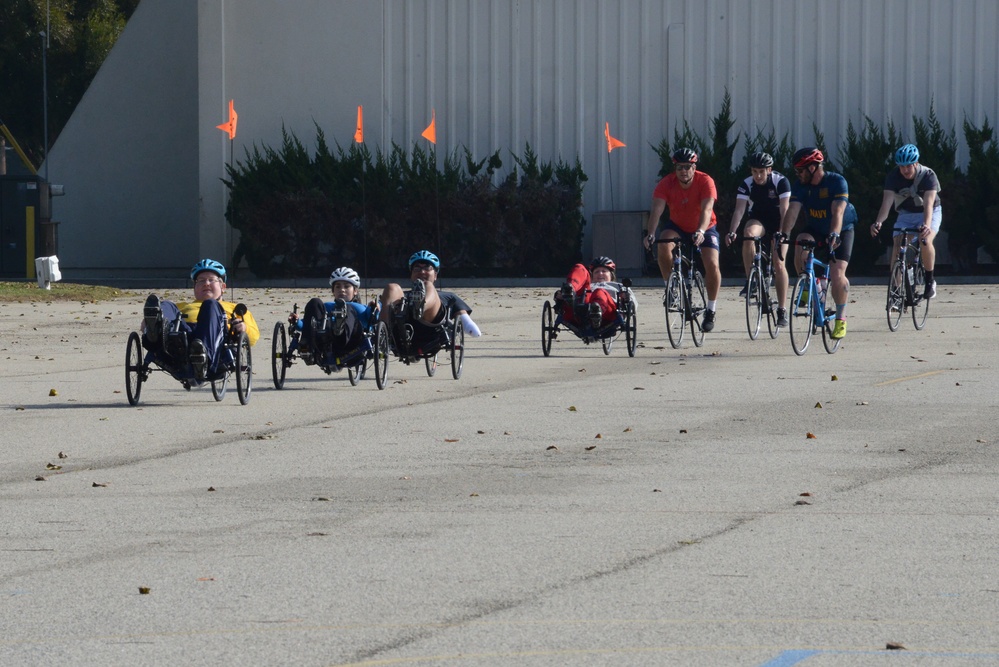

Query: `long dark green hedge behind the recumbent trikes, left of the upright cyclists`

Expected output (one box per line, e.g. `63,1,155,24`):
226,126,586,278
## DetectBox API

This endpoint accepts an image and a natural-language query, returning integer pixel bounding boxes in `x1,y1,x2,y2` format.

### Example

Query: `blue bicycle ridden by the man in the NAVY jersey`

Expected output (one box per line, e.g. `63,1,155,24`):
788,241,839,357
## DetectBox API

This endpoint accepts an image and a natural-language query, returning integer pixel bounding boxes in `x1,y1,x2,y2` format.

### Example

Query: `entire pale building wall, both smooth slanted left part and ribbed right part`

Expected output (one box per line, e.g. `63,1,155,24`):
43,0,999,276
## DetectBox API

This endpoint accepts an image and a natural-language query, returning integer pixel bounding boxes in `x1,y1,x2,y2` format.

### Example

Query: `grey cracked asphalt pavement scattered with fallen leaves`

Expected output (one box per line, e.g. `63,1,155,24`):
0,284,999,667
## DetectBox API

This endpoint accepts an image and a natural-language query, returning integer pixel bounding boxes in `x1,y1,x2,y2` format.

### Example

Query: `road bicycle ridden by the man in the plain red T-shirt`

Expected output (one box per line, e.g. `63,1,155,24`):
655,238,708,349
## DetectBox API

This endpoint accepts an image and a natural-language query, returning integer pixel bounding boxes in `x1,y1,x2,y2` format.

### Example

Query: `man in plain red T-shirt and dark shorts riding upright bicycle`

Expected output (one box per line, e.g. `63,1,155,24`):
645,148,721,331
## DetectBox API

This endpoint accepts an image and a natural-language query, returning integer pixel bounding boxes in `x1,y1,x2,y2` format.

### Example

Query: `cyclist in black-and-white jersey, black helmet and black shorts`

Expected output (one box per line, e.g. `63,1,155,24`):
725,152,791,327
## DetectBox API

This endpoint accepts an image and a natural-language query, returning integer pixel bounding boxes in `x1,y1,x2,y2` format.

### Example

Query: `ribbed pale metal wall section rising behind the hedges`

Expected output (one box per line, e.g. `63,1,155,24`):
383,0,999,222
